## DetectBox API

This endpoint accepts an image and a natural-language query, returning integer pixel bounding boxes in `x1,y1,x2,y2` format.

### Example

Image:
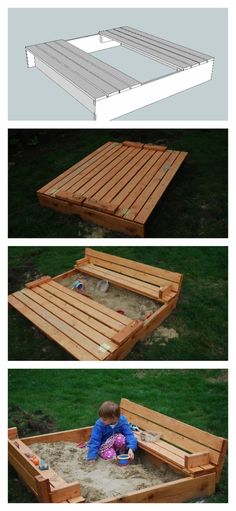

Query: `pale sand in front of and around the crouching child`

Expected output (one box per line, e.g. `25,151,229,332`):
30,442,183,502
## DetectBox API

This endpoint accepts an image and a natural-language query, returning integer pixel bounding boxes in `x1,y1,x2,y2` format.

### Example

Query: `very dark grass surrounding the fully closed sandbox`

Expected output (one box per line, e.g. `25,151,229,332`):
9,129,228,238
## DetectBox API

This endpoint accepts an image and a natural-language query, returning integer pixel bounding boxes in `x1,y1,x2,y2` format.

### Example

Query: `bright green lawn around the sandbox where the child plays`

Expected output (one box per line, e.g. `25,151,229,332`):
9,369,228,503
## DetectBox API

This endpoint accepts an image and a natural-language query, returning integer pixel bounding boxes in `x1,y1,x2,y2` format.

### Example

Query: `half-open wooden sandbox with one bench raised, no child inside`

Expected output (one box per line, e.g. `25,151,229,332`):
8,248,182,360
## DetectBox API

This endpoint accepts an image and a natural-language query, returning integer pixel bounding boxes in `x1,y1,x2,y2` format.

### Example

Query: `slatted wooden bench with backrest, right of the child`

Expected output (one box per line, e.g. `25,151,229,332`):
121,399,227,483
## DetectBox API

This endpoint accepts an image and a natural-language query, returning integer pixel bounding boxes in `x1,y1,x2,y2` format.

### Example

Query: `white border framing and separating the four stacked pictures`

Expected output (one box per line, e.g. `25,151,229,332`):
0,0,233,511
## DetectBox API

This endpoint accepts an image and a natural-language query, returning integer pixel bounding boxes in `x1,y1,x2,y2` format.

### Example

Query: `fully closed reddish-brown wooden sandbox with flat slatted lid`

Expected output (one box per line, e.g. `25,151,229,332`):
37,142,188,236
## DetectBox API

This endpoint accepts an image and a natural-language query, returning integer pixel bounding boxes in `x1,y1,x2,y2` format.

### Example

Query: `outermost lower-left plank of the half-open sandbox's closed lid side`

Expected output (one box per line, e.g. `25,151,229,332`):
8,295,97,360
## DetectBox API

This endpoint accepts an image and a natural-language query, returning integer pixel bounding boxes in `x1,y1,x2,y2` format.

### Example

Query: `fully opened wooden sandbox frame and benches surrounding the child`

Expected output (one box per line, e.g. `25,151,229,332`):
8,399,227,503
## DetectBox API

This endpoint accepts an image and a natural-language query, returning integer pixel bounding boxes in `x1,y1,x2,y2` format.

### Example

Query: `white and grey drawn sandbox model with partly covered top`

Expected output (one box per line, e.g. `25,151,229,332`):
25,26,214,121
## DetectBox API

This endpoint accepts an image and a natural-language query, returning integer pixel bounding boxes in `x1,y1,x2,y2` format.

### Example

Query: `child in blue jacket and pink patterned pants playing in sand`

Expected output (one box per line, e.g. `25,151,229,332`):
87,401,137,463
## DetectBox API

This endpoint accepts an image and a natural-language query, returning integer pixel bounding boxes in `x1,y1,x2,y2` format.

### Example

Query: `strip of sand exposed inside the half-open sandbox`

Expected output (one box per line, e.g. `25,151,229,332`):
60,272,160,319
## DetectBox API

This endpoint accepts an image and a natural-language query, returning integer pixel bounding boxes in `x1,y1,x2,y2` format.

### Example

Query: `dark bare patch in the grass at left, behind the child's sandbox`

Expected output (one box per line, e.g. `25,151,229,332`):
9,405,55,437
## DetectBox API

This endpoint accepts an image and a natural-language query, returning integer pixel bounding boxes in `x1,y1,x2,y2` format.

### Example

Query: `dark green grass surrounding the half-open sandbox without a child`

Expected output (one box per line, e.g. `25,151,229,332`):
9,247,228,360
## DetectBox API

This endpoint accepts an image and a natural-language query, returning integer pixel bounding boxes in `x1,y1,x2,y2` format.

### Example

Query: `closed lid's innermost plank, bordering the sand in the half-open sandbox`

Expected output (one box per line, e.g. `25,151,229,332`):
50,282,131,330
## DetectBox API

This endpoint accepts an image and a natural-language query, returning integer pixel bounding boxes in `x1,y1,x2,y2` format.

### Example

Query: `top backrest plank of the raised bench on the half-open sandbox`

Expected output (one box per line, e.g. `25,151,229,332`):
85,248,182,284
